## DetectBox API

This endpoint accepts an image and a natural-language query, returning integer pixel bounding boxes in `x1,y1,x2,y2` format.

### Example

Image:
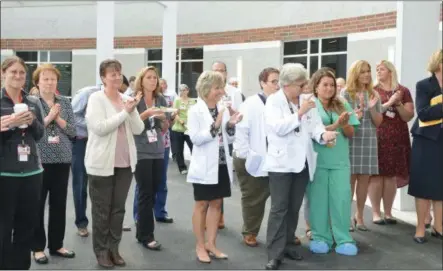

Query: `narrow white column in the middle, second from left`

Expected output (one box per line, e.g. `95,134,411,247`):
162,1,178,93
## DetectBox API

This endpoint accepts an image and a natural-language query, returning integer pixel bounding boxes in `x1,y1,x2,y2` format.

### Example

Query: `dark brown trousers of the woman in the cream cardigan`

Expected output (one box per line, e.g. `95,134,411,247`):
88,167,132,256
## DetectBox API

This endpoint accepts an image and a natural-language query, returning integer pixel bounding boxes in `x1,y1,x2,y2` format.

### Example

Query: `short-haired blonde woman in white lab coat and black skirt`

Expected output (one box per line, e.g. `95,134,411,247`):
187,71,242,263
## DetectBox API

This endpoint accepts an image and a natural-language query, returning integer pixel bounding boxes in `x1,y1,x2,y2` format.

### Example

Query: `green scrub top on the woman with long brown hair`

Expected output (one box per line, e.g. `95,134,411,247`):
314,99,360,169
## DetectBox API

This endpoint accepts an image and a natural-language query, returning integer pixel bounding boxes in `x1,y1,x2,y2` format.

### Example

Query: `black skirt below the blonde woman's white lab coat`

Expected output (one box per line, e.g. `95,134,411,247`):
192,165,231,201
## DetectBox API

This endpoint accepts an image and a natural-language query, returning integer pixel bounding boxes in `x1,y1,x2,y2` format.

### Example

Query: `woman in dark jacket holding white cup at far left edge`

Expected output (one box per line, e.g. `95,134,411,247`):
0,56,45,270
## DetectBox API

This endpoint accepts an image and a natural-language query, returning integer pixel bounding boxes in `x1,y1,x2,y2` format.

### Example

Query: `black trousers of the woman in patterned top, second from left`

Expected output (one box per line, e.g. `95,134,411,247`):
32,164,71,252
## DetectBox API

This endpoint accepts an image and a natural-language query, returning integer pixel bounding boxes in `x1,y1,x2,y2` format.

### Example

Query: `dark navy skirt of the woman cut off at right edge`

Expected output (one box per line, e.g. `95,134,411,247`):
408,131,443,201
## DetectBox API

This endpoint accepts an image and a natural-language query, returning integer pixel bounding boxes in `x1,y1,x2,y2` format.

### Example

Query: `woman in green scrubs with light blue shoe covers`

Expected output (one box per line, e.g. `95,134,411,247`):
307,68,360,255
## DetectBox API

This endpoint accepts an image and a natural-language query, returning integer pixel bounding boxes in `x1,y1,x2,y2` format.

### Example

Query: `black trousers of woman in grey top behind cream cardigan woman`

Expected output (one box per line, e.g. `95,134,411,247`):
135,159,164,243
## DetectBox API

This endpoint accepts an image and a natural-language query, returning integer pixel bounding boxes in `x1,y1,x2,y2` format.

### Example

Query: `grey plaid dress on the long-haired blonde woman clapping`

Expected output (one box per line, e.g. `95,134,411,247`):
344,90,381,175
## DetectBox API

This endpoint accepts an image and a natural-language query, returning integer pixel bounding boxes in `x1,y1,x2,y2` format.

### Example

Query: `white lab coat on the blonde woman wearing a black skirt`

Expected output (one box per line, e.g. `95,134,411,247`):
187,98,234,184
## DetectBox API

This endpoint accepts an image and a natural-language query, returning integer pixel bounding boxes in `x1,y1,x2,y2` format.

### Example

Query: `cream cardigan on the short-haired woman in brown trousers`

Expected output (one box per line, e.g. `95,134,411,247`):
85,91,145,176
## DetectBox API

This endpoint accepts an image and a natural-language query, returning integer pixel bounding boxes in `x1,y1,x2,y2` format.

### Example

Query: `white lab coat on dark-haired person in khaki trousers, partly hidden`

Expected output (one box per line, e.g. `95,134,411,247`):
234,95,268,177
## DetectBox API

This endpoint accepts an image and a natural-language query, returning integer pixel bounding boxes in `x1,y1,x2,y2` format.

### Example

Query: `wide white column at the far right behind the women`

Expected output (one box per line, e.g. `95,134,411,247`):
394,1,441,211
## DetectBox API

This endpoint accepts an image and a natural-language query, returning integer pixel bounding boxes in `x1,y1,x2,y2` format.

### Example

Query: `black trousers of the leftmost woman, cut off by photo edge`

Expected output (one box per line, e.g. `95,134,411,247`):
0,174,42,270
